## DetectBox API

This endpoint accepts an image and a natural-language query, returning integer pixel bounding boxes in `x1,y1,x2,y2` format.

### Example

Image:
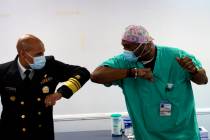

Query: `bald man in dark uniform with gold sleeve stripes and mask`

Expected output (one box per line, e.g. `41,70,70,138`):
0,34,90,140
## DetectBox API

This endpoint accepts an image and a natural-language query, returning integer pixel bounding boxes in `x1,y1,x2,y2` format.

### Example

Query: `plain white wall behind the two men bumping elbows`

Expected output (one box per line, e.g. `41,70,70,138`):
0,0,210,117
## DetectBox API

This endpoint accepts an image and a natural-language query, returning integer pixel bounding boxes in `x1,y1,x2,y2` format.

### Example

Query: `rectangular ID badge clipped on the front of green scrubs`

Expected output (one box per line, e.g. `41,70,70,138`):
160,101,171,116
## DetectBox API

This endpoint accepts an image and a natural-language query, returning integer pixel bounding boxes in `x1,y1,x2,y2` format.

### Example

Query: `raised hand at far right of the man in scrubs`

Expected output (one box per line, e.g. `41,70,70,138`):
176,57,197,73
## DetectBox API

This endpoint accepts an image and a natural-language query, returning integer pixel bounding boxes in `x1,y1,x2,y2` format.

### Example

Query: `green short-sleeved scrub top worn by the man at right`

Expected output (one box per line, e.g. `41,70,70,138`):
102,46,202,140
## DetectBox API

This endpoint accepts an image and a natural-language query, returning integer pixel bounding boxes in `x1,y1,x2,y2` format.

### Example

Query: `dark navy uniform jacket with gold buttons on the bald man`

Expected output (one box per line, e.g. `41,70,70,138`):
0,56,90,140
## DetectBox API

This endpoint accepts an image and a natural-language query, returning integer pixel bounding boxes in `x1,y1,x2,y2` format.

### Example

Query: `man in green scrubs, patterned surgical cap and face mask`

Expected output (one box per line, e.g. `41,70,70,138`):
91,25,208,140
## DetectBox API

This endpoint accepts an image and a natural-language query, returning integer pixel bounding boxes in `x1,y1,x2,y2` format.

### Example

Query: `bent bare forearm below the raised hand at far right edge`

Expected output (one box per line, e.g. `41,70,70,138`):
191,69,208,85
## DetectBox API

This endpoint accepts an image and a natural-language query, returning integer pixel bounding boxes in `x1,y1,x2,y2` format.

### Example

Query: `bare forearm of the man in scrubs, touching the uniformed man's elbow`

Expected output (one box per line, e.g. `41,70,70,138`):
91,66,128,84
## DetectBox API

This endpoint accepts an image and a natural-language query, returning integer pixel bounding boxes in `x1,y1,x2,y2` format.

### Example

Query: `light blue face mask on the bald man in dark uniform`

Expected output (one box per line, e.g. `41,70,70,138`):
27,53,46,70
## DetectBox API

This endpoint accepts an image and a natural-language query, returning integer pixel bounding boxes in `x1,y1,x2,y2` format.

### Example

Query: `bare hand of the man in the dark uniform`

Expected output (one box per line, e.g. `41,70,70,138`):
44,92,62,107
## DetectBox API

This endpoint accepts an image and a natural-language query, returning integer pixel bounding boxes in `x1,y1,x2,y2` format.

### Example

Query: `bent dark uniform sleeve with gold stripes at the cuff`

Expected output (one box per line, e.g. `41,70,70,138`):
46,55,90,98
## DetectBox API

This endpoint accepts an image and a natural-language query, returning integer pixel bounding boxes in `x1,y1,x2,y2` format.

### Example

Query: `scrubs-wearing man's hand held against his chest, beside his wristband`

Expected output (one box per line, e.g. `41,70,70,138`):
137,68,153,81
